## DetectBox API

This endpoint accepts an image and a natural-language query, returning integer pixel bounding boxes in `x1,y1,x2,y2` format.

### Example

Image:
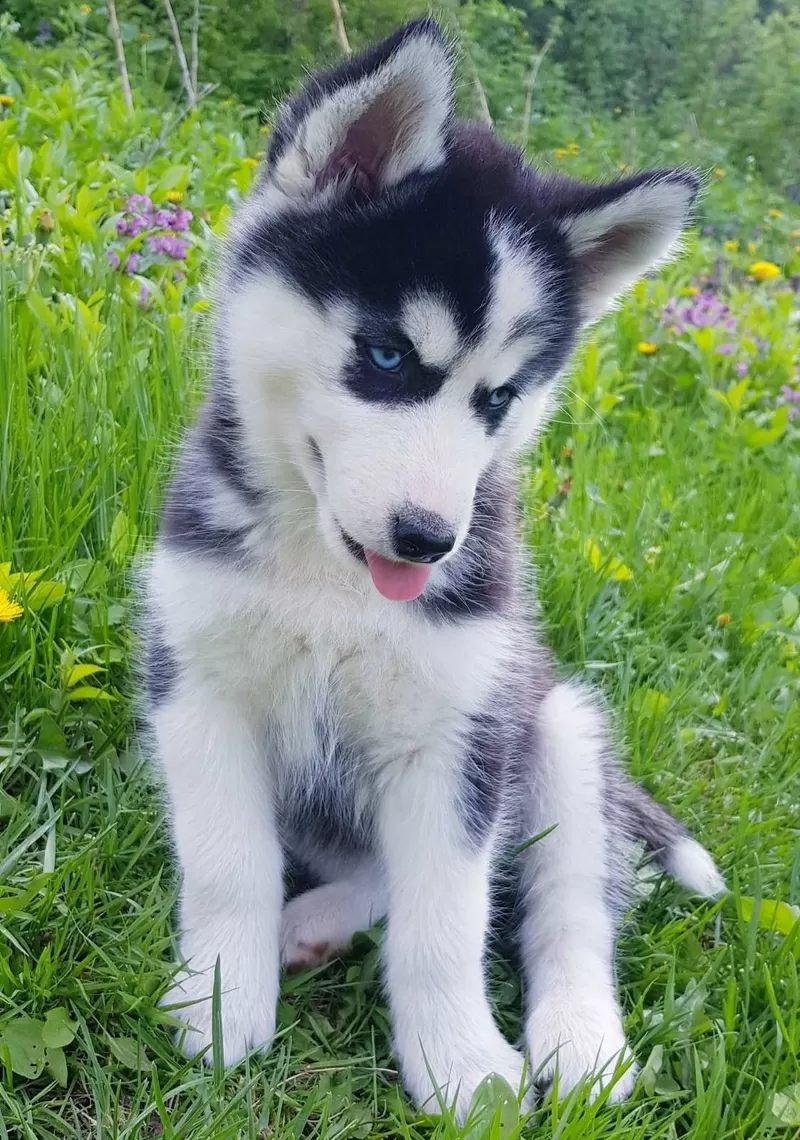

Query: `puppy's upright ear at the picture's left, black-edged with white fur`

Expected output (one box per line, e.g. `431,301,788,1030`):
262,18,454,205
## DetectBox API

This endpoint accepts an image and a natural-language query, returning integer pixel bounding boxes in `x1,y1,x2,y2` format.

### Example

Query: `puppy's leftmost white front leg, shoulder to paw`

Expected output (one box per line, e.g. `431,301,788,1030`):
153,683,283,1065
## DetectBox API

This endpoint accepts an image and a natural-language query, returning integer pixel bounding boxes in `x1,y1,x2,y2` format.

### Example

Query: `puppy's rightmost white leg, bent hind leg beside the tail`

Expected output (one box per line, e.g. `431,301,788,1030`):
521,685,636,1100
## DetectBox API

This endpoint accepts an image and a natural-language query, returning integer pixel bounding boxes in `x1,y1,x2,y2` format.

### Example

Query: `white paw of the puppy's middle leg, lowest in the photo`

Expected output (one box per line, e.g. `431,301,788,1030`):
398,1029,525,1124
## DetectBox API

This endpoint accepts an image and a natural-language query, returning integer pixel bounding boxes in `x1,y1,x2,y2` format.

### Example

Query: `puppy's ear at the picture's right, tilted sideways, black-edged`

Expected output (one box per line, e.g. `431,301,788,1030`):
554,170,700,321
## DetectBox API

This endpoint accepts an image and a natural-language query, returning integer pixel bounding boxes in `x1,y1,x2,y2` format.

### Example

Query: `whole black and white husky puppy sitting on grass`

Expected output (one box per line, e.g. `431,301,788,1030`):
146,19,724,1117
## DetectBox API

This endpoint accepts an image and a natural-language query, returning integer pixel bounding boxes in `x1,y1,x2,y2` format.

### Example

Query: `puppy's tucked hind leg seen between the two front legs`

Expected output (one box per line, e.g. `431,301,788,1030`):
280,862,386,967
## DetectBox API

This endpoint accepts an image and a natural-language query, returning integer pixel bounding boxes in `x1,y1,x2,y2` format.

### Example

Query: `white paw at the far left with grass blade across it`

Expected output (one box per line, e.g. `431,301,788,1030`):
162,939,278,1067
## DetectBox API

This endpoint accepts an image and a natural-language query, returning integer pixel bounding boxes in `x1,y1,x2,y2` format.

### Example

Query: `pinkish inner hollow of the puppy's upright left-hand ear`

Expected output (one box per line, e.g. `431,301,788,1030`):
315,93,403,196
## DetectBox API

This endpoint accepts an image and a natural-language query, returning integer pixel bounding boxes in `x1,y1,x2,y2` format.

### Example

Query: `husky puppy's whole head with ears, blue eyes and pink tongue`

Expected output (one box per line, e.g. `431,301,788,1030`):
225,21,696,600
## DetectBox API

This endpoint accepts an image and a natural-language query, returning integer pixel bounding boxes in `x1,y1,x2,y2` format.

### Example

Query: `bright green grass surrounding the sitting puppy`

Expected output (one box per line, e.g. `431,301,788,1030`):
0,24,800,1140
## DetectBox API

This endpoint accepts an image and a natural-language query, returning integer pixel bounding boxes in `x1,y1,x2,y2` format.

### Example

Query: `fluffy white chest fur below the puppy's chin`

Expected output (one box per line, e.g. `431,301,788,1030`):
150,517,519,853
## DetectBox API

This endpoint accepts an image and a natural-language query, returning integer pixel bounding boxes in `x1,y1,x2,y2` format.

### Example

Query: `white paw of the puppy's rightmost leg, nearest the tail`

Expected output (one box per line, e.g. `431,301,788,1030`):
525,990,636,1101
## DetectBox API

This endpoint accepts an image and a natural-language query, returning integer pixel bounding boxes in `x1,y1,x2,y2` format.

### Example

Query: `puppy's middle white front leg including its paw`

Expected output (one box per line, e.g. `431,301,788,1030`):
379,746,523,1119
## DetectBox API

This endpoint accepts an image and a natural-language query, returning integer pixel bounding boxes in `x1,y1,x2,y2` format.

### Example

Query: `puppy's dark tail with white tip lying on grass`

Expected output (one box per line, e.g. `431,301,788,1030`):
623,781,727,898
